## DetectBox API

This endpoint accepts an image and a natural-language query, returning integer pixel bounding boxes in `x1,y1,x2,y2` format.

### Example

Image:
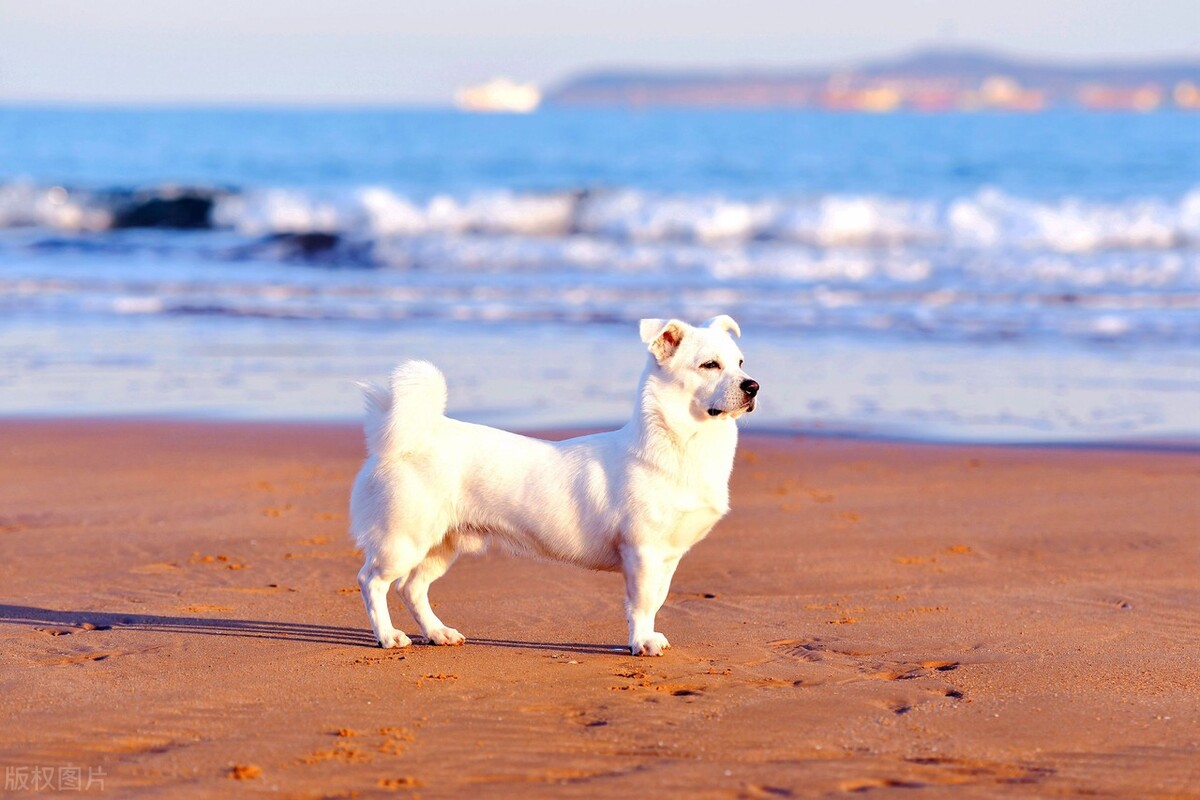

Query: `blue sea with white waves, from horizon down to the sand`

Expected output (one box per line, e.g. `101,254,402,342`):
0,108,1200,443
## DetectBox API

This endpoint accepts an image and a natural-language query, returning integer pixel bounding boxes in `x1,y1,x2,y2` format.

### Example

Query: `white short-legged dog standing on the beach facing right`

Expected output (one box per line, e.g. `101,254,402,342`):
350,314,758,656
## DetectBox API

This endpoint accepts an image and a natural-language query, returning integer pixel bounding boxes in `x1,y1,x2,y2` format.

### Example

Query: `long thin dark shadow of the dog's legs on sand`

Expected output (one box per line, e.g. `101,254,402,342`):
0,604,629,655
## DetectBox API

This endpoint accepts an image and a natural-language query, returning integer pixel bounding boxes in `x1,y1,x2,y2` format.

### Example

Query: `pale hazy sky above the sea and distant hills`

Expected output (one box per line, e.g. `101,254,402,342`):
0,0,1200,104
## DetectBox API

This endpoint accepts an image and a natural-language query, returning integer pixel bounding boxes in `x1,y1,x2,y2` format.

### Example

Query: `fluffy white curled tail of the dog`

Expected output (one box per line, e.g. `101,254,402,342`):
359,361,446,456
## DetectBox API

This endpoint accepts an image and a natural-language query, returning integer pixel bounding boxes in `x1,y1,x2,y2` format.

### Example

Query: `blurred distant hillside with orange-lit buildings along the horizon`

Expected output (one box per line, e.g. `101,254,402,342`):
545,49,1200,112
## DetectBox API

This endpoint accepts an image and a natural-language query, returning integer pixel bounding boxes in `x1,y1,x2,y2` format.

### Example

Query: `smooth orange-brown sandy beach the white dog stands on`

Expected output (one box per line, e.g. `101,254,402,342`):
0,421,1200,798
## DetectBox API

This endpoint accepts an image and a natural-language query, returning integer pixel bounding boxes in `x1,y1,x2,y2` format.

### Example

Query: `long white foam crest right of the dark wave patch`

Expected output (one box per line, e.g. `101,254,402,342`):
214,187,1200,253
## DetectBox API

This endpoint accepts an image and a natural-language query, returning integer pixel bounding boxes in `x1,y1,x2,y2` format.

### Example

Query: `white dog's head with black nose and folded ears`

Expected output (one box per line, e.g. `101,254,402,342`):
640,314,758,421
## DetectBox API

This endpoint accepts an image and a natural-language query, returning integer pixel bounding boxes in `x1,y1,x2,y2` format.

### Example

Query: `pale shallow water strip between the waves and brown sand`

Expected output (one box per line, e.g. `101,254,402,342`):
0,315,1200,443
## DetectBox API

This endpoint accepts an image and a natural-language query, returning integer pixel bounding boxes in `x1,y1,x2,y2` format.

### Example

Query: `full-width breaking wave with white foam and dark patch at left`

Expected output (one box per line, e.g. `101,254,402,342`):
0,182,1200,253
